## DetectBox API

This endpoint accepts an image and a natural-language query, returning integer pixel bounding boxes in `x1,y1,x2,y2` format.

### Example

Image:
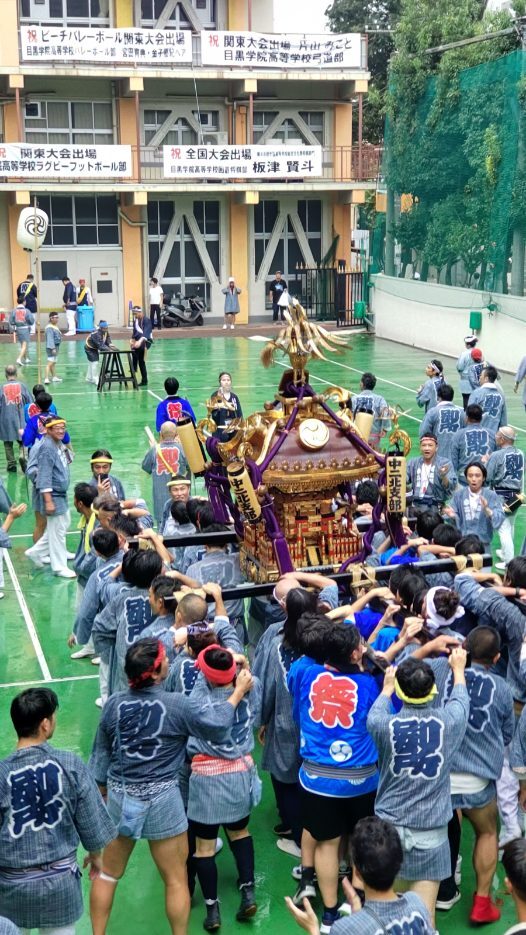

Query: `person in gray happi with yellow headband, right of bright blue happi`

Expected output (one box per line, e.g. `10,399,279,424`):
367,648,469,918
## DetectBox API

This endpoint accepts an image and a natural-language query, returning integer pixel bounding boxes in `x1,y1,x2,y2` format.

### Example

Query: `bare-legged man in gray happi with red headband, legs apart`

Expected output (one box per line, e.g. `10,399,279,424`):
90,639,252,935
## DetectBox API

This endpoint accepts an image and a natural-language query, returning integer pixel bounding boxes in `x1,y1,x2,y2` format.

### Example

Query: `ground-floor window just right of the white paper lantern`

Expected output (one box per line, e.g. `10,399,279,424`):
38,195,119,247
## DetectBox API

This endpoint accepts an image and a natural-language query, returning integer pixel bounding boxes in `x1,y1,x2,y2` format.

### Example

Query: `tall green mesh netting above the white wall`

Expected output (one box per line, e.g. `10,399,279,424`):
383,51,526,292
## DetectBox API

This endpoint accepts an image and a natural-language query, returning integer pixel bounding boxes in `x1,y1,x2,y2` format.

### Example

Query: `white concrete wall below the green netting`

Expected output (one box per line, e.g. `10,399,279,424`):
371,274,526,373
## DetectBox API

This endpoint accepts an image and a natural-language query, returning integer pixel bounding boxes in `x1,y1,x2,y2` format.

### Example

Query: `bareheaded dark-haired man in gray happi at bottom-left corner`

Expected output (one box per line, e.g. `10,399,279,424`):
0,686,117,935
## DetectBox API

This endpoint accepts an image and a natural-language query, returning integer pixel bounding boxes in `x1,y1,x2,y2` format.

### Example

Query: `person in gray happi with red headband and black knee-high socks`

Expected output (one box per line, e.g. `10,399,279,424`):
187,645,261,931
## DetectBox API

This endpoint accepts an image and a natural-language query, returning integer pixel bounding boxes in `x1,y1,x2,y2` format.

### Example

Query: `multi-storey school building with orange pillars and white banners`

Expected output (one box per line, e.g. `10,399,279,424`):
0,0,378,324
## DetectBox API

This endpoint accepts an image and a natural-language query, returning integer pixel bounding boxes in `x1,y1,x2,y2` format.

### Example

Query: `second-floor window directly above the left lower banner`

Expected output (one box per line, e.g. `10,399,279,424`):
25,101,113,145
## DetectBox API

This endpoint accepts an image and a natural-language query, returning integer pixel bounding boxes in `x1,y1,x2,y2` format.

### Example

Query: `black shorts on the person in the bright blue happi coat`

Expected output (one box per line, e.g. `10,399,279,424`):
300,786,376,841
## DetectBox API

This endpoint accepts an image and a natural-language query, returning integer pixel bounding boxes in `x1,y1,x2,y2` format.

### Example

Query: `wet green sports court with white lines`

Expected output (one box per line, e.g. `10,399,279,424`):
0,329,526,935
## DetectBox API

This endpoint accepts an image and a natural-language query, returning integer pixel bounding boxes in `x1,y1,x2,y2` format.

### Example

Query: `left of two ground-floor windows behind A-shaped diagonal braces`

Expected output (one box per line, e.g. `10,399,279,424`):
148,201,220,303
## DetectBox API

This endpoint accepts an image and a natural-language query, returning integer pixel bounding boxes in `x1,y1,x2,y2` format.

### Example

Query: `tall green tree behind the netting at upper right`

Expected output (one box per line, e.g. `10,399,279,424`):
386,0,526,288
